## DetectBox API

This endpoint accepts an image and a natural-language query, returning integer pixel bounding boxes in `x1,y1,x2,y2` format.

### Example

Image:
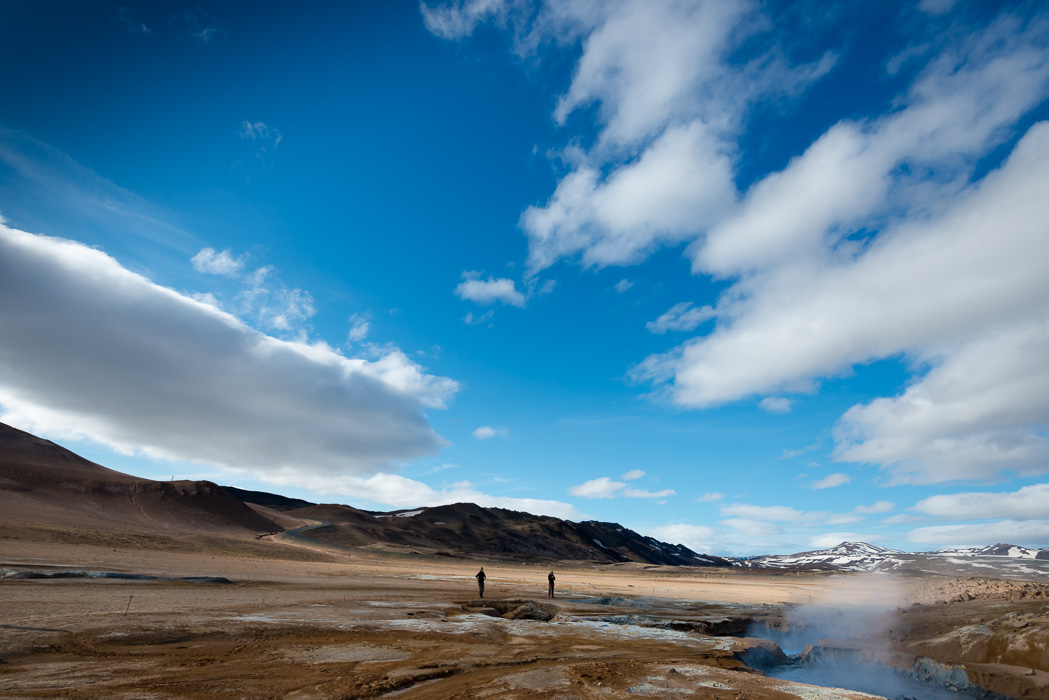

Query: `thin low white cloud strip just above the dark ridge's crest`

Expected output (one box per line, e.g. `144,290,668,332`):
295,473,582,521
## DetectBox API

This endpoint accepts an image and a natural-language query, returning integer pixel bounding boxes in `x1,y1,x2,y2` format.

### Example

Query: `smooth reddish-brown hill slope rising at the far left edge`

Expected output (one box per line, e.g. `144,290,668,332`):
0,423,281,534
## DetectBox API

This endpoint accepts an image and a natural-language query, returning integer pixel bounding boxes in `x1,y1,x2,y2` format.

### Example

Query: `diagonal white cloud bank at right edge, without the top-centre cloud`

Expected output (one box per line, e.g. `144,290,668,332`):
637,19,1049,483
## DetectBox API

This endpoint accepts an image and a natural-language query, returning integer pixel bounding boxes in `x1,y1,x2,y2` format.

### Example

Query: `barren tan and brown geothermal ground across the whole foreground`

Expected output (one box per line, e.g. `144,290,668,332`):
0,531,1049,700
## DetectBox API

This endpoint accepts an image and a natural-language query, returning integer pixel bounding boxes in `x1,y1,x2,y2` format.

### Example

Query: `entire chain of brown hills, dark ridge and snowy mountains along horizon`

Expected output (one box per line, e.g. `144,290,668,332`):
0,423,1049,573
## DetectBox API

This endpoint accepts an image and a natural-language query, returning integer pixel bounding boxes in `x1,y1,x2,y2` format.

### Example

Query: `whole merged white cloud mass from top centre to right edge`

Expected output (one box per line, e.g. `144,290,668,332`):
434,0,1049,491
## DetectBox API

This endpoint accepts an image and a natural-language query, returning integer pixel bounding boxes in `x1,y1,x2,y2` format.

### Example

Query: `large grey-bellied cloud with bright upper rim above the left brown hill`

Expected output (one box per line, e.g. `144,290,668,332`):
0,226,457,481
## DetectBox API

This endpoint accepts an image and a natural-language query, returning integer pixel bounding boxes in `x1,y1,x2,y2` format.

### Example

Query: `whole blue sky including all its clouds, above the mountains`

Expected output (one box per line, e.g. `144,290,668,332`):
0,0,1049,554
